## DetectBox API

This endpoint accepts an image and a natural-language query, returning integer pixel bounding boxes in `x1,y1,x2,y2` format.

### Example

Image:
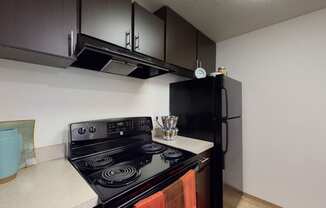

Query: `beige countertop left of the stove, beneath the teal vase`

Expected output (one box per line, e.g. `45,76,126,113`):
0,159,97,208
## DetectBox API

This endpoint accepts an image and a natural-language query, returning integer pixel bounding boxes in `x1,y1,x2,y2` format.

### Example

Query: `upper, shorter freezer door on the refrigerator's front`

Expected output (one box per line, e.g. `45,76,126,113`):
221,77,242,118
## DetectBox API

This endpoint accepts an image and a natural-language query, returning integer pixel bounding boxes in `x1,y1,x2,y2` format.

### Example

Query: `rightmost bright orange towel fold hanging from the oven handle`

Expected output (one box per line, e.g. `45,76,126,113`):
181,170,197,208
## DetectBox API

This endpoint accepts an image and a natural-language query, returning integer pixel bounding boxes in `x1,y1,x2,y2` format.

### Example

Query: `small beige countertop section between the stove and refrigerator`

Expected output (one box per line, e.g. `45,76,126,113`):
153,136,214,154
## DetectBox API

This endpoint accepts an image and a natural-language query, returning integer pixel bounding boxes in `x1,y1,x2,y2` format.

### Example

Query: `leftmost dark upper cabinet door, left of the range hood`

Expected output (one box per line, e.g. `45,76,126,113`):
0,0,77,57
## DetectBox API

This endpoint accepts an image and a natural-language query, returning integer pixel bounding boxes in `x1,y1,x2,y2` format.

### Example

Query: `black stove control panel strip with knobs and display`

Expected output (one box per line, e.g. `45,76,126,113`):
70,117,153,141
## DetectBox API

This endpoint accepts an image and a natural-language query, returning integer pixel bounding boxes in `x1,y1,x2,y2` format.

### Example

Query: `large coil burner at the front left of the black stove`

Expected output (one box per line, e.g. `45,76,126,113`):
97,164,140,187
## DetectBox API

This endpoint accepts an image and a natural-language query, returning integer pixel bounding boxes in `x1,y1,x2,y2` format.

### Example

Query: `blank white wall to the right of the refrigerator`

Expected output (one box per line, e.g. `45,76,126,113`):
217,7,326,208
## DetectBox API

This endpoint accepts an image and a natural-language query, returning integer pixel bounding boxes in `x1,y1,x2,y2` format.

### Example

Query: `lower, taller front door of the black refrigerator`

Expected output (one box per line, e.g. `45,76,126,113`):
222,118,243,208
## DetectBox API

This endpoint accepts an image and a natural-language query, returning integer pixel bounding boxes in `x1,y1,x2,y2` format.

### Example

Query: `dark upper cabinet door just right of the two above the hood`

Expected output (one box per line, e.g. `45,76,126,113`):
155,7,197,70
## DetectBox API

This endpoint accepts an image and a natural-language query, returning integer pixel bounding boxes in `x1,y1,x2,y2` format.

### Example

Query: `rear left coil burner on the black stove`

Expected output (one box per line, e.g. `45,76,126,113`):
77,154,113,170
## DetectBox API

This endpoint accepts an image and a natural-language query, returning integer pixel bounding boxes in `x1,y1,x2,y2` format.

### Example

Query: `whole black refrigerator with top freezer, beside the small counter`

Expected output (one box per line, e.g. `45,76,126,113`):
170,75,243,208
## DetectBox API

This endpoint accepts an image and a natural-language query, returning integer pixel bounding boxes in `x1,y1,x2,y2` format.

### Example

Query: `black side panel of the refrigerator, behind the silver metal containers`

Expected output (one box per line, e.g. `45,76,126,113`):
170,78,216,141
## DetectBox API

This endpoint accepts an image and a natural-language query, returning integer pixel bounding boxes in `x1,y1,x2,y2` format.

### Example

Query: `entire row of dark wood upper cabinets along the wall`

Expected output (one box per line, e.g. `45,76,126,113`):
0,0,216,76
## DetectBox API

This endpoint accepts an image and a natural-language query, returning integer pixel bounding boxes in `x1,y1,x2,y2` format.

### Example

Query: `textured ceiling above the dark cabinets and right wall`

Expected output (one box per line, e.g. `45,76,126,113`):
136,0,326,42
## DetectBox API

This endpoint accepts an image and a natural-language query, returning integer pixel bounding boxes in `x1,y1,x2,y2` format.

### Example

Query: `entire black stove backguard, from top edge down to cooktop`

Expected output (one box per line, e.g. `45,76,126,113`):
68,117,153,159
